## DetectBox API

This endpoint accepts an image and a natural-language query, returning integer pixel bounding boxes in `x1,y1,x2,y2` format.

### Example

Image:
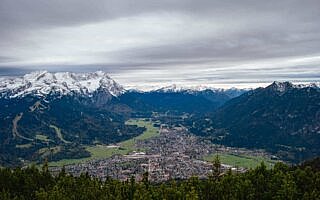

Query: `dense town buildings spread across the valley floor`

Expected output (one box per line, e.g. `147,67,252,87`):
51,127,272,182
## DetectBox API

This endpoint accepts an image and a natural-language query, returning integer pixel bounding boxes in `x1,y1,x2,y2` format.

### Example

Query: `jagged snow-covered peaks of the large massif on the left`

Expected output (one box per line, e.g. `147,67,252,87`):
0,71,124,98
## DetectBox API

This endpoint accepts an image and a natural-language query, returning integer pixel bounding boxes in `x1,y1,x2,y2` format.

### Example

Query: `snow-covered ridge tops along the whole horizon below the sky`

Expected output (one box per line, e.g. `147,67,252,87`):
0,71,320,98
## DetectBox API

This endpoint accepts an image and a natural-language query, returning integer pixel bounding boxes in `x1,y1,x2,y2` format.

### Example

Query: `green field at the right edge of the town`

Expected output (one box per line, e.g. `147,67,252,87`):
203,153,276,168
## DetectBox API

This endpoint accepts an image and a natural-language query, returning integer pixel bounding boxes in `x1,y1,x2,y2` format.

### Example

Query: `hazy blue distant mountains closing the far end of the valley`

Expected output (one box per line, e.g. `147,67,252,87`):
119,85,248,114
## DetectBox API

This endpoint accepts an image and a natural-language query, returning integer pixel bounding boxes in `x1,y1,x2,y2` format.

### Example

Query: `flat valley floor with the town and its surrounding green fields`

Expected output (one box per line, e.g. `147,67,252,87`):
50,119,275,182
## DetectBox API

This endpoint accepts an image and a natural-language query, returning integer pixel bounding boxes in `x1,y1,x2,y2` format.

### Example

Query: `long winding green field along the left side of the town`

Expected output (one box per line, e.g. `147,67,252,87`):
49,119,160,166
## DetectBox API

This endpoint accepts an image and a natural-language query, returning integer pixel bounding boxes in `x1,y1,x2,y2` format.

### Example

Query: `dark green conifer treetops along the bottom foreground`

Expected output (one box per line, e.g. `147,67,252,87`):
0,160,320,200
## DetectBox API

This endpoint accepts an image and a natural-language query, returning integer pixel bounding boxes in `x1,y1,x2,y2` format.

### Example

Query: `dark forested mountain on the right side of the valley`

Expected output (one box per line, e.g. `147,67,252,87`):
190,82,320,161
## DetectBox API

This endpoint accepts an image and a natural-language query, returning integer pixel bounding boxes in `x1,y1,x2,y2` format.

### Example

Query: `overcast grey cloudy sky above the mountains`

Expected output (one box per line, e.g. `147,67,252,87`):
0,0,320,89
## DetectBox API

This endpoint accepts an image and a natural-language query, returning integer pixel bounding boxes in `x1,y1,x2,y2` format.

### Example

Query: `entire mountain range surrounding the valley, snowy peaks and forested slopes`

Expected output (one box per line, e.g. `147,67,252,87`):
0,71,320,166
